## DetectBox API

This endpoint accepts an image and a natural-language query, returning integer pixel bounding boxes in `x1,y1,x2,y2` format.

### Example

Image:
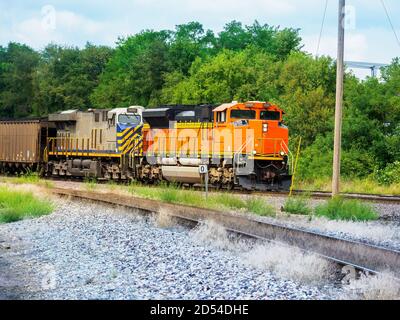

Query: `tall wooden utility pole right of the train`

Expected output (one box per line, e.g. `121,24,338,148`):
332,0,346,197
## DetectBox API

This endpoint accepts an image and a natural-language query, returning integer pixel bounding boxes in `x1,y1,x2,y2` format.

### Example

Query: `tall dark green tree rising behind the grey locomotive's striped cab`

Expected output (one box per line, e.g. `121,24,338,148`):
91,31,171,107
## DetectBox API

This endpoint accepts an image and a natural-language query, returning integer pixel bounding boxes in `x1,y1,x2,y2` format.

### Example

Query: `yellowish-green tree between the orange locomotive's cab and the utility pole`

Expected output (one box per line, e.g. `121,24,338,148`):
276,53,336,146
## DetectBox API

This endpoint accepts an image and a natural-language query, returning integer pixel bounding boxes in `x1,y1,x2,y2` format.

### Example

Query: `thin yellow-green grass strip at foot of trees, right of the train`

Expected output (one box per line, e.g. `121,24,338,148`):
295,178,400,195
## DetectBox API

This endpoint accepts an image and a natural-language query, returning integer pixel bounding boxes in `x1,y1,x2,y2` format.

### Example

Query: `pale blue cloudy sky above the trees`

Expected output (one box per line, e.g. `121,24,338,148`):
0,0,400,76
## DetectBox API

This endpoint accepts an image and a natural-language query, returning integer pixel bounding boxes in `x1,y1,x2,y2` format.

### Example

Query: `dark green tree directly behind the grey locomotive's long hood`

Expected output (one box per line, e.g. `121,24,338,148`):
34,43,113,115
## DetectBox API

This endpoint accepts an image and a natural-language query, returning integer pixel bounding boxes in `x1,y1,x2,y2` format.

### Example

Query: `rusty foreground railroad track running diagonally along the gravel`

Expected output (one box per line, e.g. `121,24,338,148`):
49,188,400,278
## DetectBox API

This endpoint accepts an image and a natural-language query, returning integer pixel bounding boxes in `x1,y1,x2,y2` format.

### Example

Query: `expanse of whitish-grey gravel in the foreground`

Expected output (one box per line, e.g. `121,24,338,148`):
0,200,340,299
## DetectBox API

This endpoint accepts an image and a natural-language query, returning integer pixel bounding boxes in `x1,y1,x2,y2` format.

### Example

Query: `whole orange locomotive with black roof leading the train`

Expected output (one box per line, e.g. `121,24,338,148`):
136,102,292,191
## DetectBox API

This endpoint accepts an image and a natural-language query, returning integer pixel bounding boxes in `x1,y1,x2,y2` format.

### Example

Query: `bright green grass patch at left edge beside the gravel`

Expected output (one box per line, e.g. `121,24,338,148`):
0,187,54,223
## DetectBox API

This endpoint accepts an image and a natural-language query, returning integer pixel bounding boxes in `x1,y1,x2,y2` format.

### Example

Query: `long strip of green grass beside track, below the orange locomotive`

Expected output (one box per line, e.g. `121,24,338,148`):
128,183,275,216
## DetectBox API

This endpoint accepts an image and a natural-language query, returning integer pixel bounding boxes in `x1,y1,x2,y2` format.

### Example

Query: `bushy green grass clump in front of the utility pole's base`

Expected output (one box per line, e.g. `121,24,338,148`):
315,197,379,221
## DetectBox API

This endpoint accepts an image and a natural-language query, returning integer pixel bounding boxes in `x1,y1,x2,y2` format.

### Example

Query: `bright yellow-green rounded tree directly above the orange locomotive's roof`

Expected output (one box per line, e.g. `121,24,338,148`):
162,47,273,104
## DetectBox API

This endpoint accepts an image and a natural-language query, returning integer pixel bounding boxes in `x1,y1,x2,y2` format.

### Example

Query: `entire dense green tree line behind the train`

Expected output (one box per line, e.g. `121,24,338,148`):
0,21,400,183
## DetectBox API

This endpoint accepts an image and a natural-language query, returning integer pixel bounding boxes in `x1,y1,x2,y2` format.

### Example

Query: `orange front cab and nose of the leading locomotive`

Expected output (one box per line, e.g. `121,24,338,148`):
214,101,291,190
